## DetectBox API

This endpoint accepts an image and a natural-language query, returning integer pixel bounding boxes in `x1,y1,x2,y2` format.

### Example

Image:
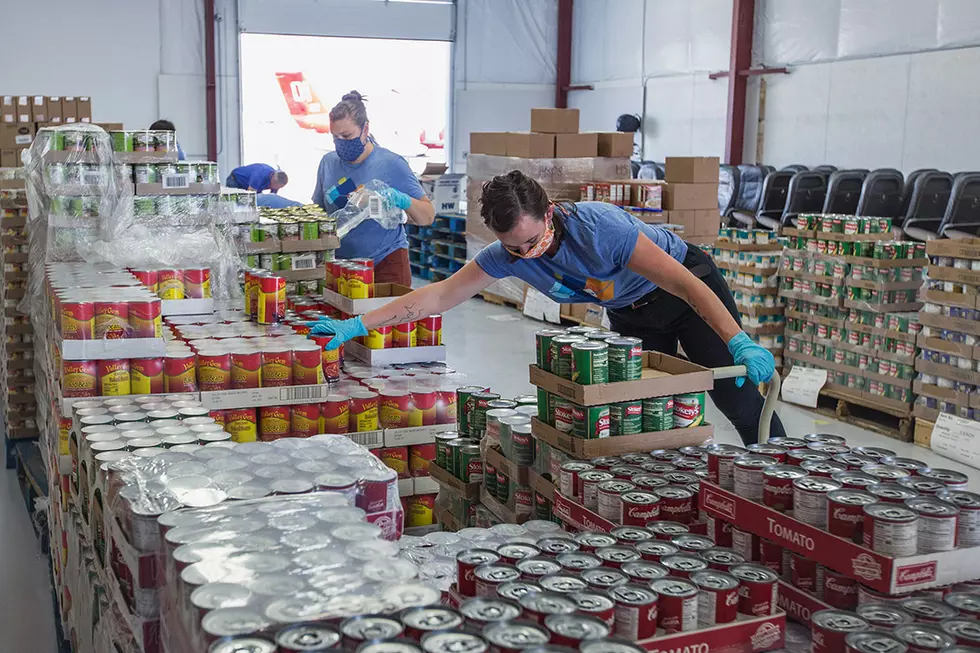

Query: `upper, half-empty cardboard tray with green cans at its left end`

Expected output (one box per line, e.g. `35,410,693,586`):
530,327,714,406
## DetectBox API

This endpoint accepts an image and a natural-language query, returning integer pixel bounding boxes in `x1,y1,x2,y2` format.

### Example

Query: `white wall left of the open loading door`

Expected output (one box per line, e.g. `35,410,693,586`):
0,0,239,170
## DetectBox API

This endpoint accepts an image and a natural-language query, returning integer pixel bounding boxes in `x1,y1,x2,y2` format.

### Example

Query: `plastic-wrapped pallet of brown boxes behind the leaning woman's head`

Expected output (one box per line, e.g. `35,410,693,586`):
466,109,633,305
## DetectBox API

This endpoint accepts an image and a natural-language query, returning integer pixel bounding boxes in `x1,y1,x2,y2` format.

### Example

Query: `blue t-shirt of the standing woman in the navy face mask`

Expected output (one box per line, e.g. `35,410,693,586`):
313,145,425,262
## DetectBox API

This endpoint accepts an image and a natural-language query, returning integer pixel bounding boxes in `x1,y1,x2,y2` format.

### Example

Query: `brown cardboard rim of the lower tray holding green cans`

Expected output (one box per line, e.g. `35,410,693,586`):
531,418,714,460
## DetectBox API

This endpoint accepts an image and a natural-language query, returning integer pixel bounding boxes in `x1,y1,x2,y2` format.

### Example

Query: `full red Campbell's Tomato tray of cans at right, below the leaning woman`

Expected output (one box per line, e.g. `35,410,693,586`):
700,434,980,605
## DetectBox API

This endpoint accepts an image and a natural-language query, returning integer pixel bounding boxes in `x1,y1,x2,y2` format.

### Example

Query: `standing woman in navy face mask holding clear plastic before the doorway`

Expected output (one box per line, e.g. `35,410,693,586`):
313,91,436,286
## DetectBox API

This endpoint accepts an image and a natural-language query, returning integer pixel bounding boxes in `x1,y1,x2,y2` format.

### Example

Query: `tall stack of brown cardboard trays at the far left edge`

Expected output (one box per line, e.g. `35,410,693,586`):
0,186,38,440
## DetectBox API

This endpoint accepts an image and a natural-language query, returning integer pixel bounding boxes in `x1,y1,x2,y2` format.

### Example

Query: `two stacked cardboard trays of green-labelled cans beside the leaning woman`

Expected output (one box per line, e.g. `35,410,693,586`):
531,327,714,458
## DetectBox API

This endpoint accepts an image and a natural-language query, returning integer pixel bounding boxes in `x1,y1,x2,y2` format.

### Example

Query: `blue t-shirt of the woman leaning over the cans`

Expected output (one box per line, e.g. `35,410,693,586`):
476,202,687,308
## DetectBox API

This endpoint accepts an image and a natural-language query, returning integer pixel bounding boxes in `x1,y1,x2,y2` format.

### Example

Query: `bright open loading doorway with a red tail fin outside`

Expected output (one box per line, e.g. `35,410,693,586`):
241,34,451,203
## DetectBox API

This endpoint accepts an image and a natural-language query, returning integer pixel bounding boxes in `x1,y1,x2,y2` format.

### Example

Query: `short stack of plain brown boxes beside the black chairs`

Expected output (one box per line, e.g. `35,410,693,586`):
662,156,721,245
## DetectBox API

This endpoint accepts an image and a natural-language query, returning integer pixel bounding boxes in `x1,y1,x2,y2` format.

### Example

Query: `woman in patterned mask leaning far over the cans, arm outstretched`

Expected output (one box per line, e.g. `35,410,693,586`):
312,171,785,443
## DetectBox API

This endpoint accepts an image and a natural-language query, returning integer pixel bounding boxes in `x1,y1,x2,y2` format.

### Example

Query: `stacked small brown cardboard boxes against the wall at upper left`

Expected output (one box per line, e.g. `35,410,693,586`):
0,95,92,168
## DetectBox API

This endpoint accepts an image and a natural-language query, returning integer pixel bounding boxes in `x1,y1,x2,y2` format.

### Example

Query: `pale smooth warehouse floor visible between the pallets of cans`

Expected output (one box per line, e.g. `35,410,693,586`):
0,299,980,653
